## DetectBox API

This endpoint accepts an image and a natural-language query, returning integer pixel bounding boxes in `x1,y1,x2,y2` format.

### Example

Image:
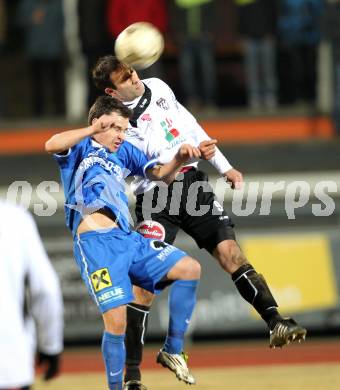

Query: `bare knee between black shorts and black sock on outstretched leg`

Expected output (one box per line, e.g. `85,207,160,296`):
214,240,247,273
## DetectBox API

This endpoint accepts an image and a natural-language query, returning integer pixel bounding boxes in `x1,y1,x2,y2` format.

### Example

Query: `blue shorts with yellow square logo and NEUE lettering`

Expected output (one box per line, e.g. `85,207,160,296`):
73,228,186,313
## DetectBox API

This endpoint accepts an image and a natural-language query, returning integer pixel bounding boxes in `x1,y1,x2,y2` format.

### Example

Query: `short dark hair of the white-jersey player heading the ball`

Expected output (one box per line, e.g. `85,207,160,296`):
92,55,131,92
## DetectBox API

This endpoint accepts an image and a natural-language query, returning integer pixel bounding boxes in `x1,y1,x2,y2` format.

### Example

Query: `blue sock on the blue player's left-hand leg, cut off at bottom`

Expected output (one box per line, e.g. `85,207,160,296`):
102,332,125,390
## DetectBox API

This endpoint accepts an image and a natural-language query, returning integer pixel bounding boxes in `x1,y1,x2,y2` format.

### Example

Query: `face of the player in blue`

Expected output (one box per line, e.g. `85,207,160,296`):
93,112,129,152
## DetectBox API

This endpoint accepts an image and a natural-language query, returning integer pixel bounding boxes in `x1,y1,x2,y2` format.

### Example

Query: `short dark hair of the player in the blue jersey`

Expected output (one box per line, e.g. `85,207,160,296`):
88,95,133,125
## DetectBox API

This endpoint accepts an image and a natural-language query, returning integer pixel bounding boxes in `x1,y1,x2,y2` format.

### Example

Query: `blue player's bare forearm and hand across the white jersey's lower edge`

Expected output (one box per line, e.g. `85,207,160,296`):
146,144,201,184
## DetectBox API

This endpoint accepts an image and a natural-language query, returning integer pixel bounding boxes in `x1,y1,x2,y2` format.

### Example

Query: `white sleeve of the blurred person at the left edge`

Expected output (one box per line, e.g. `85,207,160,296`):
21,213,64,354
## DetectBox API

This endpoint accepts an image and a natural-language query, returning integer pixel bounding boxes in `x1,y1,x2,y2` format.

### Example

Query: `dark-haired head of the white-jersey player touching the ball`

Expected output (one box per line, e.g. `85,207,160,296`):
92,55,144,102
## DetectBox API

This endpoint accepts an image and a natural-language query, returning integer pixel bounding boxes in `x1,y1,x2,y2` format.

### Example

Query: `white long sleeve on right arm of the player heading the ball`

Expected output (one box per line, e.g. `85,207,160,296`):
177,102,233,175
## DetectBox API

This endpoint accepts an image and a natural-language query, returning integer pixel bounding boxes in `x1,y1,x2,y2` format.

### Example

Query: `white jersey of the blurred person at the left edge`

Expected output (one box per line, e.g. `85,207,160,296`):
0,202,63,389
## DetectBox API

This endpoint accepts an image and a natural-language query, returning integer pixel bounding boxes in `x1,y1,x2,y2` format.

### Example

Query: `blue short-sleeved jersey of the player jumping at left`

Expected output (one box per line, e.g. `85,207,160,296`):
54,137,157,235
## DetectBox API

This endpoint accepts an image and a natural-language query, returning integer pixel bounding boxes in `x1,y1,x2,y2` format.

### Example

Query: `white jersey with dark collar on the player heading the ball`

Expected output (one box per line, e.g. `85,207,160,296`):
124,78,232,194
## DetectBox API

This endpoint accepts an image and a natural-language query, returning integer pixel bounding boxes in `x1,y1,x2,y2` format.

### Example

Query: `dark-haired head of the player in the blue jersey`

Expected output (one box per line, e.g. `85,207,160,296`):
88,95,132,152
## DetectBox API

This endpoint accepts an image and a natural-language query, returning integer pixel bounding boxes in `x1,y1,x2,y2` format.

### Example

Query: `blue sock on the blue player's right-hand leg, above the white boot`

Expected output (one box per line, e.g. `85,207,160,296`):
163,280,198,354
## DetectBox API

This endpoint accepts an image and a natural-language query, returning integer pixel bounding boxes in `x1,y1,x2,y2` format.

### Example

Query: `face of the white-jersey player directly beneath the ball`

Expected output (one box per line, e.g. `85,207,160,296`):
105,68,144,102
